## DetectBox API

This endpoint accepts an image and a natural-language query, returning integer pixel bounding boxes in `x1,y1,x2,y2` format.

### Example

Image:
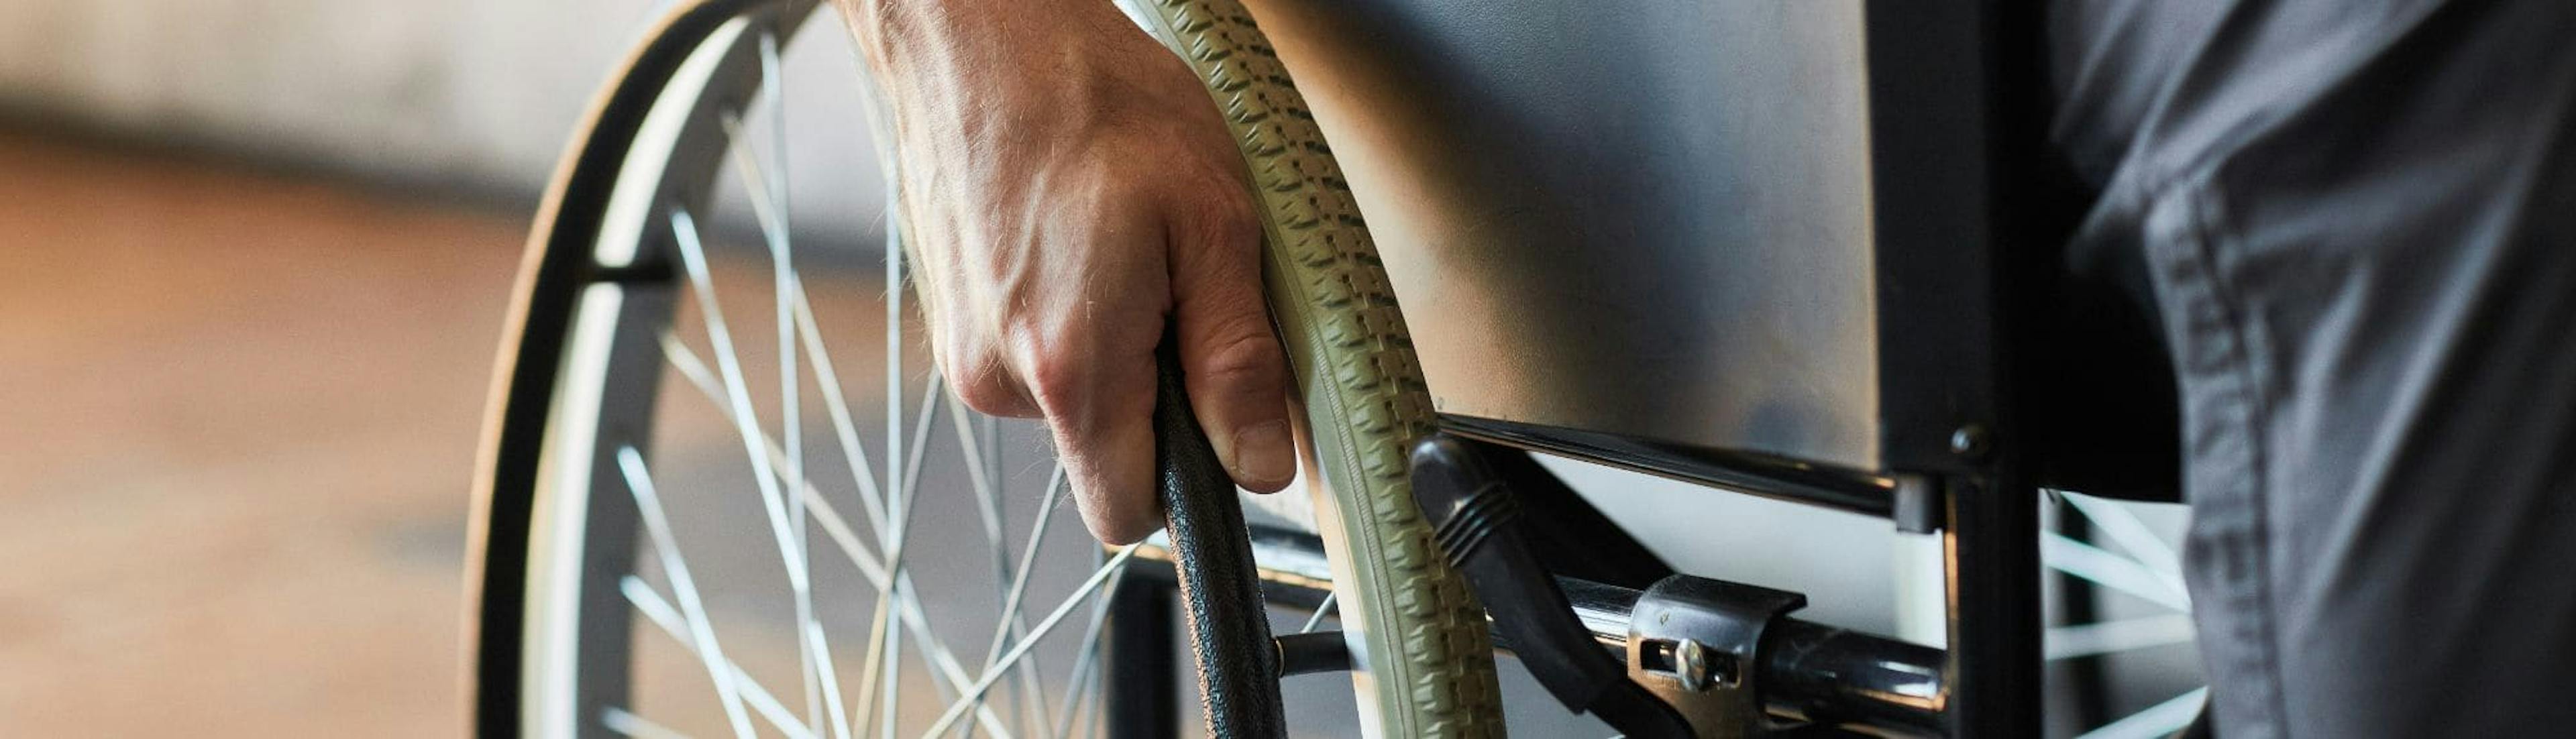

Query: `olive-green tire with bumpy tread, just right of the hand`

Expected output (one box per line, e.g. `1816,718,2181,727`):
1157,0,1502,736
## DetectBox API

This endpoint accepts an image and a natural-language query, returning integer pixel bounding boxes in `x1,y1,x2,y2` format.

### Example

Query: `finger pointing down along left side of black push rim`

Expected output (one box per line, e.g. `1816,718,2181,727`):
1030,339,1162,543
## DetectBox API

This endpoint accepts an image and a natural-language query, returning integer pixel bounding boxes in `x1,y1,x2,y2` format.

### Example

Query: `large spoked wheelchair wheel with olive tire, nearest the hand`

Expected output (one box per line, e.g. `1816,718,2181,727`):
472,0,1502,736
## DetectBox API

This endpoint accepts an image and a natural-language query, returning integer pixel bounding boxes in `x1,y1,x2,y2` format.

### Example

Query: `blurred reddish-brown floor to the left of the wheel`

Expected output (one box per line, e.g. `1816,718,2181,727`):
0,137,525,736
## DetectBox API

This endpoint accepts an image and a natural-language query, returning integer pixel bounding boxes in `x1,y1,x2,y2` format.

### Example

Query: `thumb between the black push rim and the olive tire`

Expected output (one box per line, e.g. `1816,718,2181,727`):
1172,188,1296,492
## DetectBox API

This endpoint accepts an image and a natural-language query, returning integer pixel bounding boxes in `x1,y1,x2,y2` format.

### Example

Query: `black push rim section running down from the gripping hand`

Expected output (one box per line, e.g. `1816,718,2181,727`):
1159,337,1288,739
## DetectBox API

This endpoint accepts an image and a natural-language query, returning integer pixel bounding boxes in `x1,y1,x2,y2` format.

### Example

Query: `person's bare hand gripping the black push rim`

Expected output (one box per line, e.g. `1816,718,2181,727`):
843,0,1296,543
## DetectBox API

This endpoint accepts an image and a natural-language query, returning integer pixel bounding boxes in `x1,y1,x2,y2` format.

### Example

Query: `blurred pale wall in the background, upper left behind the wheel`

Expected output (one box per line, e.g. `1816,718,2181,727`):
0,0,883,242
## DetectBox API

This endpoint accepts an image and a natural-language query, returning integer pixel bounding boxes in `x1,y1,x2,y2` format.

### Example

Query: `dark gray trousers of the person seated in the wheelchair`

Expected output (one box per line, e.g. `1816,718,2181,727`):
2045,0,2576,739
